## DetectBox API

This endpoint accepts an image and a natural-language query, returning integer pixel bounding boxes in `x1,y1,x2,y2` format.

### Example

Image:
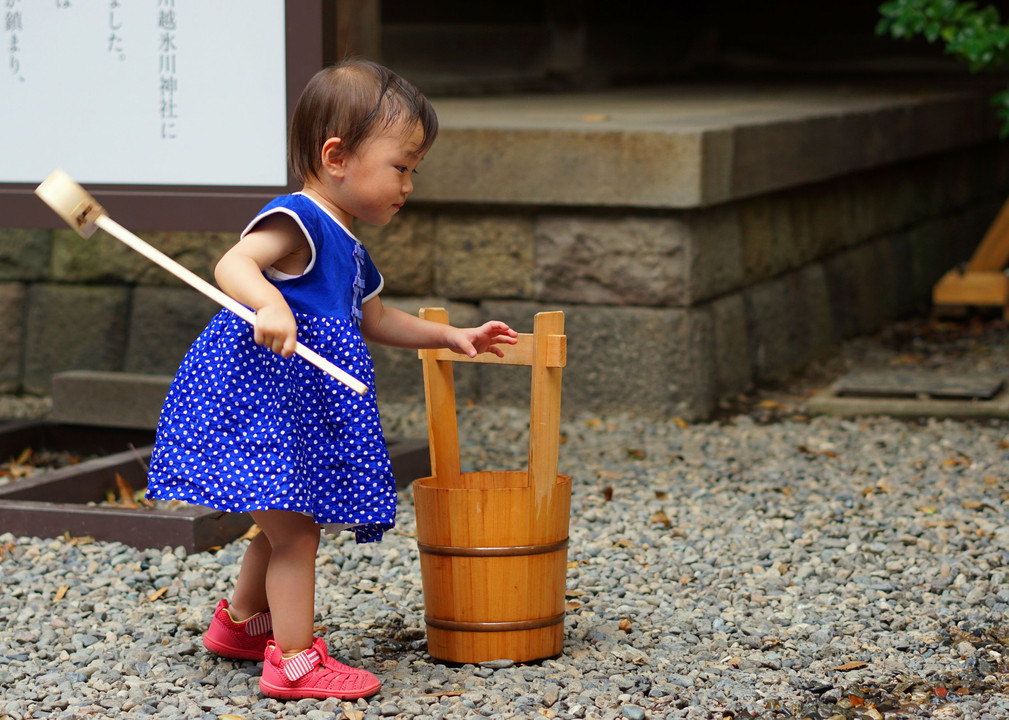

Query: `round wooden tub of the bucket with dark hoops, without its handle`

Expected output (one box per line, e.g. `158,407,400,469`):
414,472,570,663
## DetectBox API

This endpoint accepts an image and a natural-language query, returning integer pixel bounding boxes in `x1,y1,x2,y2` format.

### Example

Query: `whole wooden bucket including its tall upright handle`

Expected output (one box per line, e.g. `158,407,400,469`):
414,309,571,663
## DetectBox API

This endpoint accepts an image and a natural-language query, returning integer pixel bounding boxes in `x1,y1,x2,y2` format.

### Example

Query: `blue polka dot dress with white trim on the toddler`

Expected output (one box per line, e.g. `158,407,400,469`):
147,193,396,543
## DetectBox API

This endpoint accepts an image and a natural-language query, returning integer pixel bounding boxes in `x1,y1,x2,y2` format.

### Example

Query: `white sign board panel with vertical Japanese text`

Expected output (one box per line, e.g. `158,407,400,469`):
0,0,288,187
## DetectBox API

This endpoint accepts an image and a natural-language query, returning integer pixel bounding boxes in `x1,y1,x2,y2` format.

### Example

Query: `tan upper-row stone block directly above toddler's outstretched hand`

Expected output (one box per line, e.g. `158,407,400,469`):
435,214,535,301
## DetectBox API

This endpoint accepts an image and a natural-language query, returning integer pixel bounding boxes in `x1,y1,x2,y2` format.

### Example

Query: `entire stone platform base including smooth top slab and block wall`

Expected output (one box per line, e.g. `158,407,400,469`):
0,83,1009,417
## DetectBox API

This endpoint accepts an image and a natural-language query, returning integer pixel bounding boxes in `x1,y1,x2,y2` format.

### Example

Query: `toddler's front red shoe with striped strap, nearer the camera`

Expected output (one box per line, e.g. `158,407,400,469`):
259,637,381,700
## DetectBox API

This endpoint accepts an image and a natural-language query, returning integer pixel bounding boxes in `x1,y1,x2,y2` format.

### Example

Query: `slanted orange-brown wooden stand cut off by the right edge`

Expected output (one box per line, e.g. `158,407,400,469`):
932,196,1009,320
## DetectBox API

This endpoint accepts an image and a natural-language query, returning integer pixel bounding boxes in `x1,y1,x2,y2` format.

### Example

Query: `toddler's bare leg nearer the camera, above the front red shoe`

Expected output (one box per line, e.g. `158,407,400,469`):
248,510,320,656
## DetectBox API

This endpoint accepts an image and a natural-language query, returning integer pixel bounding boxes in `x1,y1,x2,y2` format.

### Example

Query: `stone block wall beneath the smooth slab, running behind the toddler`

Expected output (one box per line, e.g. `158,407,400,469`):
0,142,1009,417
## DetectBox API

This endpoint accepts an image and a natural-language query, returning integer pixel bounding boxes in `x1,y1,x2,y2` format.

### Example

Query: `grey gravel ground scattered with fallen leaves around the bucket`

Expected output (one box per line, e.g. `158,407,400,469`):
0,320,1009,720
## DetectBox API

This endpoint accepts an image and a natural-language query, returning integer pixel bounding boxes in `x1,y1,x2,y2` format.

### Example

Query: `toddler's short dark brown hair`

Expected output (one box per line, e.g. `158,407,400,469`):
288,59,438,183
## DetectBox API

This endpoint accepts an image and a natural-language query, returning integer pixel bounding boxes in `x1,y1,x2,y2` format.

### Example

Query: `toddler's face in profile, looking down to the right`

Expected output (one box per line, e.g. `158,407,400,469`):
336,124,424,225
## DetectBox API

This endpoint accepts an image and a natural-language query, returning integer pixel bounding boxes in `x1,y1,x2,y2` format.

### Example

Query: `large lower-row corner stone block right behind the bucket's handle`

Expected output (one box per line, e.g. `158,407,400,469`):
480,302,715,419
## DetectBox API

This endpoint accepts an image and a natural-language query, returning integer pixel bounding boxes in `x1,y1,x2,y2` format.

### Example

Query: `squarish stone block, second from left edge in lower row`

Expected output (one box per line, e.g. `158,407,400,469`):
24,284,130,394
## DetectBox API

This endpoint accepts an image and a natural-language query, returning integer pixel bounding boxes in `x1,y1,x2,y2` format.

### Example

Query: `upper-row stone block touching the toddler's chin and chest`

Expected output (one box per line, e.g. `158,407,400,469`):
354,210,435,297
